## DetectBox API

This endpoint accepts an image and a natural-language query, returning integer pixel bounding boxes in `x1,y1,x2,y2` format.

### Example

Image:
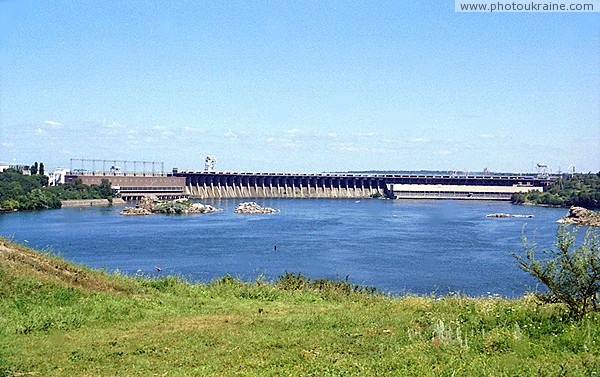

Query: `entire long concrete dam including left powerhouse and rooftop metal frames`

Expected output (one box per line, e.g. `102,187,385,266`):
65,156,555,200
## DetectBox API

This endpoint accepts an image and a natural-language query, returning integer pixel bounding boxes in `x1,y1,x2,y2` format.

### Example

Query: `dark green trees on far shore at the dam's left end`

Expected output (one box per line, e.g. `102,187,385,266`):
0,166,115,210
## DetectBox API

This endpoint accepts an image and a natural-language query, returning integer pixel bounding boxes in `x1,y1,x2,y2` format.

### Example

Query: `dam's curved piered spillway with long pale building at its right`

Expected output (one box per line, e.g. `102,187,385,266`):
173,171,551,200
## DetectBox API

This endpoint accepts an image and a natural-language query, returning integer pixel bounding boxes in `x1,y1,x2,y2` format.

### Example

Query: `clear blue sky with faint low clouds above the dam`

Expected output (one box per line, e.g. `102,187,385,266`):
0,0,600,172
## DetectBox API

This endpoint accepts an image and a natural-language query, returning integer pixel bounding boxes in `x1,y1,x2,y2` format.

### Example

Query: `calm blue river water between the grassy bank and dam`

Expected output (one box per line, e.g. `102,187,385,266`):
0,199,566,296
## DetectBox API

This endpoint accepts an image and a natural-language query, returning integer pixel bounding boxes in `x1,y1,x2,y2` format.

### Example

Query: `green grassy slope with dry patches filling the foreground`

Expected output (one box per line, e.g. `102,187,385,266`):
0,239,600,376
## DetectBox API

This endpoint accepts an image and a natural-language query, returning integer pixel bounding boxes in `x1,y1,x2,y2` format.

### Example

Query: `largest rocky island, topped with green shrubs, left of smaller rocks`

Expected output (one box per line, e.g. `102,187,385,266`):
121,195,222,216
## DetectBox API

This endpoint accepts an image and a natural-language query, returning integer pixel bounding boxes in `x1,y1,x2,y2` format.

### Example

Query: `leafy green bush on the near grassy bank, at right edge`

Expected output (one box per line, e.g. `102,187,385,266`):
513,225,600,319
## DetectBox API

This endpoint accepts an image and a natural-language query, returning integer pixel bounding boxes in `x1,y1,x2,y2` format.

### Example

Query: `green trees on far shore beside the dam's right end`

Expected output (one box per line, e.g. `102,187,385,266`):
511,172,600,209
